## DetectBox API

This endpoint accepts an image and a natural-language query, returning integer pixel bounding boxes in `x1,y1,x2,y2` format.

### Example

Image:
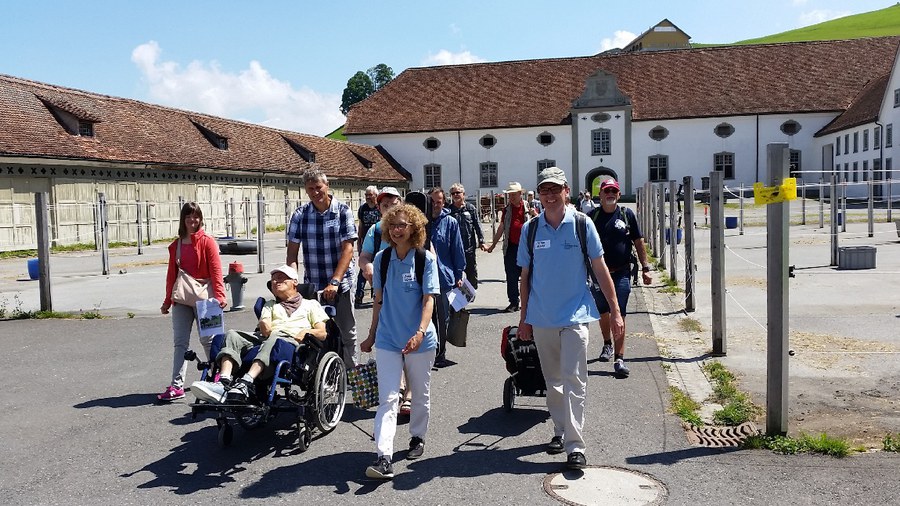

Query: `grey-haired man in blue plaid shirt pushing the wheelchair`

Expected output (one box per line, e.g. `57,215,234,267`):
285,169,358,369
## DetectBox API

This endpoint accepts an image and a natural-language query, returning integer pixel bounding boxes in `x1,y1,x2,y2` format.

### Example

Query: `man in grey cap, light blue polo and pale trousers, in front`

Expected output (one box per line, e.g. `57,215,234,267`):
517,167,625,469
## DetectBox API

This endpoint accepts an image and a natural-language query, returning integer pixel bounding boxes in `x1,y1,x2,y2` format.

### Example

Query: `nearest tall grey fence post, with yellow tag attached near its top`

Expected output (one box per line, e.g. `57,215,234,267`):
766,143,791,435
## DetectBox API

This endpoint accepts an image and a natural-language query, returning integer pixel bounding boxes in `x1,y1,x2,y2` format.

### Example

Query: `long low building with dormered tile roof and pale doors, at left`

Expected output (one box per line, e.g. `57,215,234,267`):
0,75,410,250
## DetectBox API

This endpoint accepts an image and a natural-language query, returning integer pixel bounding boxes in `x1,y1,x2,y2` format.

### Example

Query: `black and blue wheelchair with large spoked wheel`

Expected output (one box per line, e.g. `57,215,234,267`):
185,284,347,452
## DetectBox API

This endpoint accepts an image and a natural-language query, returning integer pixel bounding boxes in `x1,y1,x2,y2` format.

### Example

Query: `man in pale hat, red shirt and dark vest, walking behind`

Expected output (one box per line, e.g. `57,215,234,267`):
486,181,529,313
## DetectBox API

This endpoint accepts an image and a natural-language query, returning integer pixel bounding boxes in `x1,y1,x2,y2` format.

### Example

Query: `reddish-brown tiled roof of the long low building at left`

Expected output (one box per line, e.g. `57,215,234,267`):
0,75,408,183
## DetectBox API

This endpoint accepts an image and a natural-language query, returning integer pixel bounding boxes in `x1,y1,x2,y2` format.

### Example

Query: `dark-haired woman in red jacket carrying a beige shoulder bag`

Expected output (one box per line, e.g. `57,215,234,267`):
157,202,225,401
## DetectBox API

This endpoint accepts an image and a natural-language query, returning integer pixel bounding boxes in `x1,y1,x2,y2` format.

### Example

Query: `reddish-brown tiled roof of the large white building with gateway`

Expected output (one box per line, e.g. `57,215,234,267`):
344,37,900,135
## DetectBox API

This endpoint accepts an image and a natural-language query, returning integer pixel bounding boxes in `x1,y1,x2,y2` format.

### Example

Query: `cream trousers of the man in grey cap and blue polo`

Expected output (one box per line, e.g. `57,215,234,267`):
533,324,588,453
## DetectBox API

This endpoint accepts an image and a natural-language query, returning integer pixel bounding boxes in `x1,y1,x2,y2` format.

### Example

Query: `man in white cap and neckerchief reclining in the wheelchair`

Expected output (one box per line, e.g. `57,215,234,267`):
191,265,328,404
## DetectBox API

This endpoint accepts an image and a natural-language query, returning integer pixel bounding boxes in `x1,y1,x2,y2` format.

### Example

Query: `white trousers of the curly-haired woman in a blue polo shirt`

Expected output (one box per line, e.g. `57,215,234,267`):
375,349,435,460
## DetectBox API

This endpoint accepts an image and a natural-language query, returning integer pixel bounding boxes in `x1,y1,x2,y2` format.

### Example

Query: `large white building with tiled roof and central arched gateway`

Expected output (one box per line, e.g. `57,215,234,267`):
344,37,900,195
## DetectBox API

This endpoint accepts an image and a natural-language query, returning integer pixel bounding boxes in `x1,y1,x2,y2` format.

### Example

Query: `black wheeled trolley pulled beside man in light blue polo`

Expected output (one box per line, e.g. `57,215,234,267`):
500,326,547,412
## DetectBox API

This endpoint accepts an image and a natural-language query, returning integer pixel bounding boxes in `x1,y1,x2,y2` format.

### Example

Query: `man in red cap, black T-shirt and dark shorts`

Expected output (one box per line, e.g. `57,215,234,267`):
591,178,653,378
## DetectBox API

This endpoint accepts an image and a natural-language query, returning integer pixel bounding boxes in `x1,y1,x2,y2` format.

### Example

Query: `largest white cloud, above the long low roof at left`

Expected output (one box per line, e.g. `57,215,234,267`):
131,41,345,135
